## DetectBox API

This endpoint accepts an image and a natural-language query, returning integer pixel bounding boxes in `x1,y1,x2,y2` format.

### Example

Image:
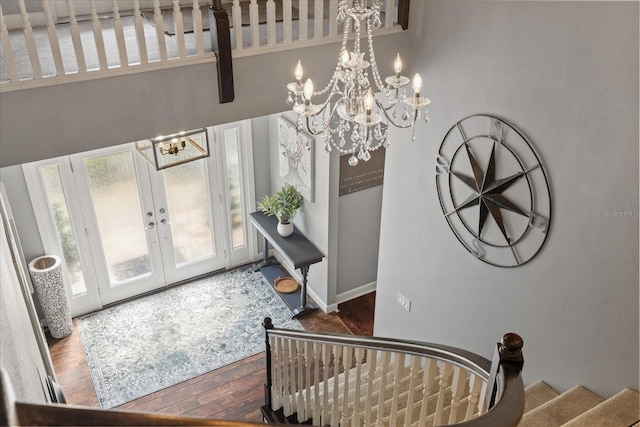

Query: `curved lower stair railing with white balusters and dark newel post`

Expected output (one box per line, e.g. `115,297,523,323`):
261,318,525,427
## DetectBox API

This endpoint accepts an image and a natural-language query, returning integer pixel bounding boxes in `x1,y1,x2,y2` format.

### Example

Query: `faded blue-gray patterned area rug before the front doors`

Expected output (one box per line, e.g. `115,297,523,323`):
76,267,303,409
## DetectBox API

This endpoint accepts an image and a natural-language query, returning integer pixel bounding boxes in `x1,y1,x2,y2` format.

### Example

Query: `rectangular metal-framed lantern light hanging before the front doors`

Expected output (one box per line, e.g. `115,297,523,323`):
135,129,211,170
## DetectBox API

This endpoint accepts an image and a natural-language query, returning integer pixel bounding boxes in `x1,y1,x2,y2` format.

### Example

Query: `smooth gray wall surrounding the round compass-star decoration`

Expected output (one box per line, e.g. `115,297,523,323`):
375,0,639,396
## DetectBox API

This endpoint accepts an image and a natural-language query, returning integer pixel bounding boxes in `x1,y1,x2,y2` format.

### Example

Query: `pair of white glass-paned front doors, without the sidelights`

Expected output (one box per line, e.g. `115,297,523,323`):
71,144,224,304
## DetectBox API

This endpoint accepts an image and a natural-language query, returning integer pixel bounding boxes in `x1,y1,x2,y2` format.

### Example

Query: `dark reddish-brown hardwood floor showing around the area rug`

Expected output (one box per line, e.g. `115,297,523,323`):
47,292,375,422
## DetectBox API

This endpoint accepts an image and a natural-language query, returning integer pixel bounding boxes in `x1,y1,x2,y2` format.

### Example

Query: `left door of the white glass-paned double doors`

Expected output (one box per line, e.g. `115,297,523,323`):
71,144,165,304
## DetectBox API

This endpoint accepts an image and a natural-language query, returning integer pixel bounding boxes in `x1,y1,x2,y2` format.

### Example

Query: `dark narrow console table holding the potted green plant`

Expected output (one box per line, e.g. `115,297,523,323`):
250,212,324,318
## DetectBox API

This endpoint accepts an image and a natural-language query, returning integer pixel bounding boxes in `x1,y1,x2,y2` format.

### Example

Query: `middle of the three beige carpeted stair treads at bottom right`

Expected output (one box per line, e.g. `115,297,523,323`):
518,386,604,427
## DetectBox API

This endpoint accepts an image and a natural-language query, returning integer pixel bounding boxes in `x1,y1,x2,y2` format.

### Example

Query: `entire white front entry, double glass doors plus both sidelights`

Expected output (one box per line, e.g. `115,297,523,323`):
23,122,256,316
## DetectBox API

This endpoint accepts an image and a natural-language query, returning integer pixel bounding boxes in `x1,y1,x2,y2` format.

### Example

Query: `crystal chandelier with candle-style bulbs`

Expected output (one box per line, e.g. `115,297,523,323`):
287,0,431,166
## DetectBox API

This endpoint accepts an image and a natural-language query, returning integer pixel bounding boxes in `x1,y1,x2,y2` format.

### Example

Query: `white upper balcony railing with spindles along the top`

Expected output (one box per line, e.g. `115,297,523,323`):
0,0,408,91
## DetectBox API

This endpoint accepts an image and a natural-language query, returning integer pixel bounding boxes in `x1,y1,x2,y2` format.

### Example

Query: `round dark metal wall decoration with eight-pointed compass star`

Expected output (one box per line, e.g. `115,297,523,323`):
436,114,551,267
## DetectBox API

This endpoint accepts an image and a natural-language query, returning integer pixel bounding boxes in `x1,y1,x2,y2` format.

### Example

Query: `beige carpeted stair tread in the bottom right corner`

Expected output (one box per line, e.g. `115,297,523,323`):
564,388,640,427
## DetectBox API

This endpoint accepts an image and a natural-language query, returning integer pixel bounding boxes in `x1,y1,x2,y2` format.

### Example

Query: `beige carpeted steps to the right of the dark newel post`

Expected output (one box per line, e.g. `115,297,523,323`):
518,381,640,427
